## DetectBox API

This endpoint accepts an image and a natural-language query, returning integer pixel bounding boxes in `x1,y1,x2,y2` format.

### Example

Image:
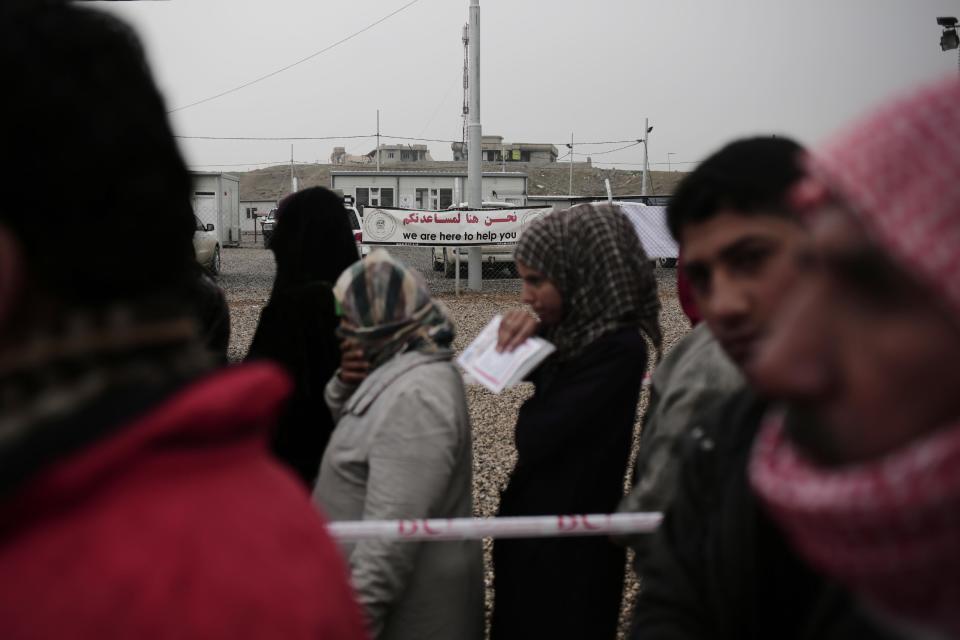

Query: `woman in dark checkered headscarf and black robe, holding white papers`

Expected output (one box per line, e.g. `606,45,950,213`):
491,205,661,640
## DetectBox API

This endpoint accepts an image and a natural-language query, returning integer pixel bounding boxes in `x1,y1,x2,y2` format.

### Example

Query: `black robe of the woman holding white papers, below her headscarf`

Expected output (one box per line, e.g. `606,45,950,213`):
491,329,647,640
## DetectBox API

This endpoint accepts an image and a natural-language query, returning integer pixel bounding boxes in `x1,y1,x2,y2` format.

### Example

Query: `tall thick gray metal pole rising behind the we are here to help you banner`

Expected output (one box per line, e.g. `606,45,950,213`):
467,0,483,291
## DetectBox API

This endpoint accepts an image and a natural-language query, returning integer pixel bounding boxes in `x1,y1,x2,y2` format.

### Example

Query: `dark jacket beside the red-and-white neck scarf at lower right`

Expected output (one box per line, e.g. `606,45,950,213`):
632,389,893,640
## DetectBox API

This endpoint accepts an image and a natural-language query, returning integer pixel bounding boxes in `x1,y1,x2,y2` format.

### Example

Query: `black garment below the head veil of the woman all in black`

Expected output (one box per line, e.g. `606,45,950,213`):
247,282,340,489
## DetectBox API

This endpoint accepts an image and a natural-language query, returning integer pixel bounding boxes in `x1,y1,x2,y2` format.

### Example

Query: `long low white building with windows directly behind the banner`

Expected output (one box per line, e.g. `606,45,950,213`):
330,171,527,209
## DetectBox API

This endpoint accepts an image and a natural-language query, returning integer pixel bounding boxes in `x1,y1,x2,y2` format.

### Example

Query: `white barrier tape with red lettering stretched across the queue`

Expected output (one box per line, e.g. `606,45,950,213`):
327,512,663,542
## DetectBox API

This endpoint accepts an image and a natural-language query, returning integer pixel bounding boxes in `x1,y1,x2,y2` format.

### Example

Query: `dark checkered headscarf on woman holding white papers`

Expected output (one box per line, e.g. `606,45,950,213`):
515,204,661,363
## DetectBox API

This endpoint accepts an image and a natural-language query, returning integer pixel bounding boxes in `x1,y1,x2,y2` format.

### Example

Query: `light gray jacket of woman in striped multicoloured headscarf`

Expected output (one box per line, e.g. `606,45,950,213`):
313,352,484,640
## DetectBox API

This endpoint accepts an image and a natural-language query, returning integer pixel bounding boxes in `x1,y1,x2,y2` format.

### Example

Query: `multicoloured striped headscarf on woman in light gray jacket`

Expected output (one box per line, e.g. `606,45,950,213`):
333,249,455,368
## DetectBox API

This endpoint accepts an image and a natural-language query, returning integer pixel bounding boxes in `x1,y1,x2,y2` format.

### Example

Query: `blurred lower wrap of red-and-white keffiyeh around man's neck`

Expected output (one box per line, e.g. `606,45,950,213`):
750,417,960,637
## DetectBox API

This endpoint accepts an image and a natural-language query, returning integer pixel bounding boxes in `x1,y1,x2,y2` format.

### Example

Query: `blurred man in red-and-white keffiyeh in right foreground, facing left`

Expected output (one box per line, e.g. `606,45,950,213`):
633,80,960,640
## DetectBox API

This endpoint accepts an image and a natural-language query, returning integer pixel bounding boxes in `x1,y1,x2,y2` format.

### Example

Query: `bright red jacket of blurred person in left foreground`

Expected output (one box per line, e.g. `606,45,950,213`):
0,365,365,640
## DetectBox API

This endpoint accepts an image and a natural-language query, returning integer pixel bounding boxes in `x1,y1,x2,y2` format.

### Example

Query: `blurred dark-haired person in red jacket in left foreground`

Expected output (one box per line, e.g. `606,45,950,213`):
0,2,363,640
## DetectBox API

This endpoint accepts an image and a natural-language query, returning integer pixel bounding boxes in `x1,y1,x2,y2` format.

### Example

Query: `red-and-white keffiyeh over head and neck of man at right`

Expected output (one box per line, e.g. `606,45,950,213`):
750,79,960,638
